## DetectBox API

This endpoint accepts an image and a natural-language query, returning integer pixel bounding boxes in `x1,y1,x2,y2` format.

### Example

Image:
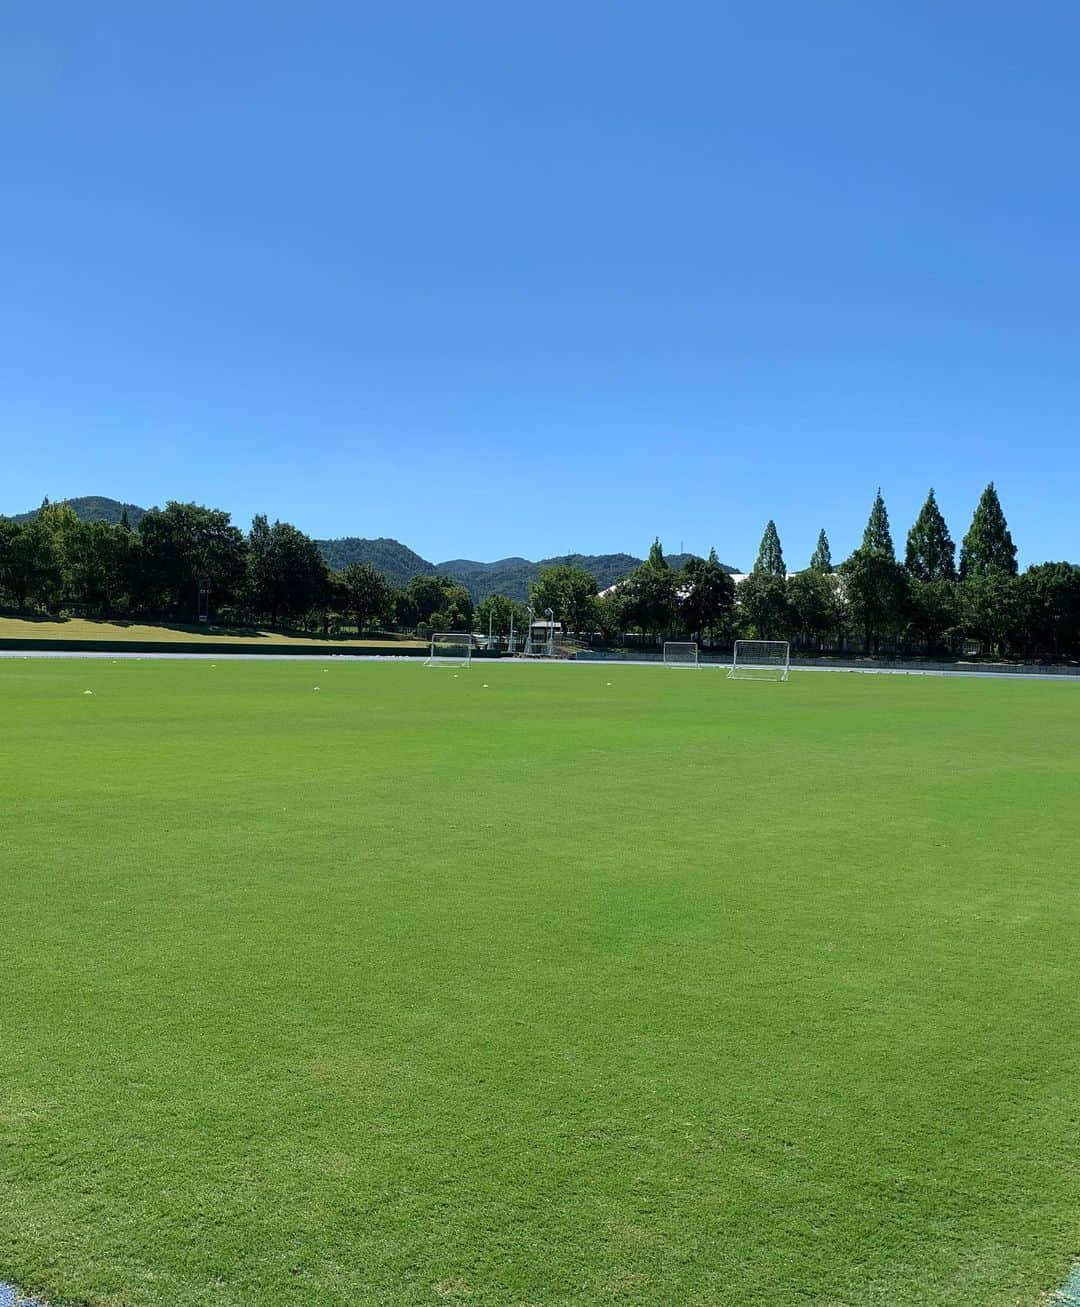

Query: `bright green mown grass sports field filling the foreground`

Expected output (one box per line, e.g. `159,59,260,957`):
0,661,1080,1307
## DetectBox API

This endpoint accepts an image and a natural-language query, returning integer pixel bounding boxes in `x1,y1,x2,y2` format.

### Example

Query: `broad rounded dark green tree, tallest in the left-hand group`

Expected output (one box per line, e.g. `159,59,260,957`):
139,501,247,621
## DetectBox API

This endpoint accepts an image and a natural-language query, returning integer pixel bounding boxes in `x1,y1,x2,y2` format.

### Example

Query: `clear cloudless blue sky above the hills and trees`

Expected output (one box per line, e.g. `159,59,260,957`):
0,0,1080,567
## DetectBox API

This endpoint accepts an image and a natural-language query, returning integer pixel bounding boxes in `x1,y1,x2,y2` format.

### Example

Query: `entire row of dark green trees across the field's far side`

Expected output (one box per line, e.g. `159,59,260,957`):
0,484,1080,657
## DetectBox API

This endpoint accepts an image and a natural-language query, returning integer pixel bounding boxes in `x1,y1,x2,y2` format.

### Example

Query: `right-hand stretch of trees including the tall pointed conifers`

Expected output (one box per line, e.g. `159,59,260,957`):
475,482,1080,659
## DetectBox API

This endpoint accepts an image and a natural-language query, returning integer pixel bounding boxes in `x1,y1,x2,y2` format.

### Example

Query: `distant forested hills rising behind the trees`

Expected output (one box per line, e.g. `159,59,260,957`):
8,495,736,603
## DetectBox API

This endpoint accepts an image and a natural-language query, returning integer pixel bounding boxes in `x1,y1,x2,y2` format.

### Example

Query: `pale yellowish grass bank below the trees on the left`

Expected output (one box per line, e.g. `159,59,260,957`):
0,617,421,652
